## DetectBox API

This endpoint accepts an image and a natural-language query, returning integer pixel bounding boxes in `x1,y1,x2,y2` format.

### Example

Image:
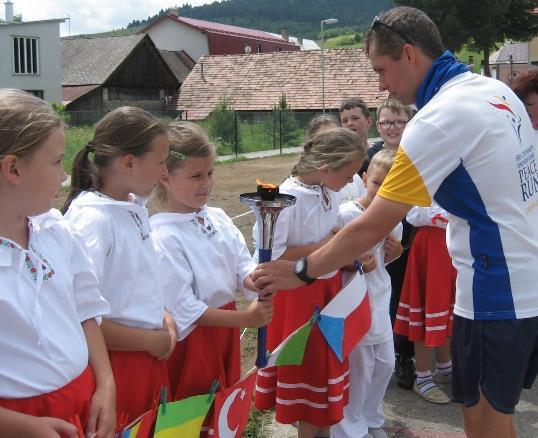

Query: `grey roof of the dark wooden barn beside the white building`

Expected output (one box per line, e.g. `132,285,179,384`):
61,35,146,85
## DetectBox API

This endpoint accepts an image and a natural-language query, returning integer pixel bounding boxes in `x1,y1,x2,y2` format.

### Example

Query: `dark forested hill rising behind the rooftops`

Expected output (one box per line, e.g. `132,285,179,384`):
127,0,393,39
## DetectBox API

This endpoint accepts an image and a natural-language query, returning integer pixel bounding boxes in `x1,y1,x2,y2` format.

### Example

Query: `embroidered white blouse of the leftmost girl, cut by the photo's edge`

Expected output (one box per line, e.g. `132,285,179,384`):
0,210,109,398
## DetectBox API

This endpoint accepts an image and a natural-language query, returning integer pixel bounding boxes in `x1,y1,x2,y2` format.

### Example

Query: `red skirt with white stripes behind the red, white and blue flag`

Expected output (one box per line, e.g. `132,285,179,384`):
255,273,349,427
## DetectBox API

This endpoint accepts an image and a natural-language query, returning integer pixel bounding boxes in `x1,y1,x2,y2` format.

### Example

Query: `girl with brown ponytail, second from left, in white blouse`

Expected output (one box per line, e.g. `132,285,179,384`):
63,107,176,425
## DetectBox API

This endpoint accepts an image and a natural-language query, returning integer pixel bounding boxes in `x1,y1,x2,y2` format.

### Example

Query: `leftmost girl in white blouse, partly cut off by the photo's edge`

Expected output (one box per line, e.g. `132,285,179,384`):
0,89,115,438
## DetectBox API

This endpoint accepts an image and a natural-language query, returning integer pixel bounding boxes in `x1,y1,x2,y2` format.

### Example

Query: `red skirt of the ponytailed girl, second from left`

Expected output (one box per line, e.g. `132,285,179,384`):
108,351,170,426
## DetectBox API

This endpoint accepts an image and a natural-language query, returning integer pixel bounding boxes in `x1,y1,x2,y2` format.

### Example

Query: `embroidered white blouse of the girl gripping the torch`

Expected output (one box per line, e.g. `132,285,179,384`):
150,207,258,340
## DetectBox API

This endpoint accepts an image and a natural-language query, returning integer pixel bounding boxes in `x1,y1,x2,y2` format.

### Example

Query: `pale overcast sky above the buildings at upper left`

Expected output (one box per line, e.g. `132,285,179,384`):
7,0,209,36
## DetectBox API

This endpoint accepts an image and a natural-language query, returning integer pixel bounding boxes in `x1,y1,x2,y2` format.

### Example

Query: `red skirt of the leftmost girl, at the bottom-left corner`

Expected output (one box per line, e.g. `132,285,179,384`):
0,366,95,428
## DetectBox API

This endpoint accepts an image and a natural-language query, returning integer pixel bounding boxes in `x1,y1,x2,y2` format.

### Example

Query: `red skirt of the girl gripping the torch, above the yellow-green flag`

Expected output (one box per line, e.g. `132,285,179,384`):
168,302,237,436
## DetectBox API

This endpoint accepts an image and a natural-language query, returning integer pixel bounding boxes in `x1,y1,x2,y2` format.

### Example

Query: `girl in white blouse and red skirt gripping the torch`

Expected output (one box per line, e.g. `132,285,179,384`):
150,123,272,432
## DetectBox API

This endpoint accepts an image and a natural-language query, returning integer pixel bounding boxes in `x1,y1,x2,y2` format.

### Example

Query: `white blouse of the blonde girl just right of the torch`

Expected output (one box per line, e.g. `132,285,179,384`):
252,176,340,278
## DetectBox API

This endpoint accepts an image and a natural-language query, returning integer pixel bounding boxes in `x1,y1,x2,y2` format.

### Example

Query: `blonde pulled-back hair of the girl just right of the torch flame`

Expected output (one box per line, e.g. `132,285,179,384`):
291,128,366,176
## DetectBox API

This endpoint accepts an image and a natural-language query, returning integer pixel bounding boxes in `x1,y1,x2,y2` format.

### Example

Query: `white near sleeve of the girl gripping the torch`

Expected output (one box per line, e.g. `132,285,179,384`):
157,248,208,341
